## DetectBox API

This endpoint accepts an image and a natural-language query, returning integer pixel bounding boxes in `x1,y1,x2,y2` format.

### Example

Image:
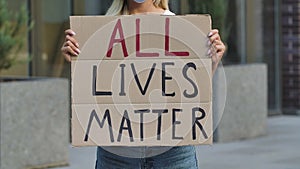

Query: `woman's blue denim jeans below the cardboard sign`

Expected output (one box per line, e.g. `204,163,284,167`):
95,146,198,169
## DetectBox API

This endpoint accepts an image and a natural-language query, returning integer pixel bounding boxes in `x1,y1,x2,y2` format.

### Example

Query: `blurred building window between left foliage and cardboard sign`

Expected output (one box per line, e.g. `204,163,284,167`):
29,0,71,77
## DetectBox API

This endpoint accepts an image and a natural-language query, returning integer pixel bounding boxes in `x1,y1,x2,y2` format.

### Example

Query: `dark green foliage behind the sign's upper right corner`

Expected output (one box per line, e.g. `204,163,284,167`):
189,0,231,43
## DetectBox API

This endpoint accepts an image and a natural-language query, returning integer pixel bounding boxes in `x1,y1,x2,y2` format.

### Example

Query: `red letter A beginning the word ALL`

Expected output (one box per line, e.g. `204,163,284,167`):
106,19,128,57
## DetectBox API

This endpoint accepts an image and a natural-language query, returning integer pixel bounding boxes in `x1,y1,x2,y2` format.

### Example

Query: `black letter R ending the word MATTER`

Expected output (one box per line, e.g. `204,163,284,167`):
192,107,208,140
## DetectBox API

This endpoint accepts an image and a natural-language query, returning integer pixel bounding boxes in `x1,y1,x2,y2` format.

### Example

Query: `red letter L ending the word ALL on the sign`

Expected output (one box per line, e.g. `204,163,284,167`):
165,18,190,56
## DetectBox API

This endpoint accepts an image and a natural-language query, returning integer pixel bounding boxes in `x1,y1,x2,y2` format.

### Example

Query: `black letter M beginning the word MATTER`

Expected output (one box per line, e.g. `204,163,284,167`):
84,109,114,143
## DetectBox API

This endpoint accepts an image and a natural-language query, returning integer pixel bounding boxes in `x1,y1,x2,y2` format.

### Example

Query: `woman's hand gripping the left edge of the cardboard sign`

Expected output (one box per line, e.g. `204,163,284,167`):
61,29,80,62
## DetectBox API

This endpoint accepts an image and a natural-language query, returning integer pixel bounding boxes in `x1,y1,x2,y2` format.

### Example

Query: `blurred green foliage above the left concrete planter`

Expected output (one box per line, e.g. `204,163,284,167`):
0,0,29,71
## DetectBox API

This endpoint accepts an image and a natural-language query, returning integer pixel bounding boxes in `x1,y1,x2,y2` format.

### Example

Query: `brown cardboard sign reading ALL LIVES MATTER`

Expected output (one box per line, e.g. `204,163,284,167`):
71,15,213,146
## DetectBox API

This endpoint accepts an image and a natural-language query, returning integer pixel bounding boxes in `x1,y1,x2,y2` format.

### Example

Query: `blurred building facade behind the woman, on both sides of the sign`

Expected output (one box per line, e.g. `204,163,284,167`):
2,0,300,114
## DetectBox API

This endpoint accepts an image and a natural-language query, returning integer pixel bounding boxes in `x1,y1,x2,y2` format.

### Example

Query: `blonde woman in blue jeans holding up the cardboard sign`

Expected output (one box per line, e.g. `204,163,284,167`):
61,0,225,169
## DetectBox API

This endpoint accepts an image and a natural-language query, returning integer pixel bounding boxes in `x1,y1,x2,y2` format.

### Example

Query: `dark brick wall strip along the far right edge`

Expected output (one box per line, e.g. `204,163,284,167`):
280,0,300,114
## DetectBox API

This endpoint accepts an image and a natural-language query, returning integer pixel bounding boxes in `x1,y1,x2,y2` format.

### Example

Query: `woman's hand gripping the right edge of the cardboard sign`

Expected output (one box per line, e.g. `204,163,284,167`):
208,29,226,73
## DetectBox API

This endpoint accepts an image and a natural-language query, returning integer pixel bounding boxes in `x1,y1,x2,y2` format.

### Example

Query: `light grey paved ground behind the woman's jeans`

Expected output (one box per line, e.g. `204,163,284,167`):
56,116,300,169
